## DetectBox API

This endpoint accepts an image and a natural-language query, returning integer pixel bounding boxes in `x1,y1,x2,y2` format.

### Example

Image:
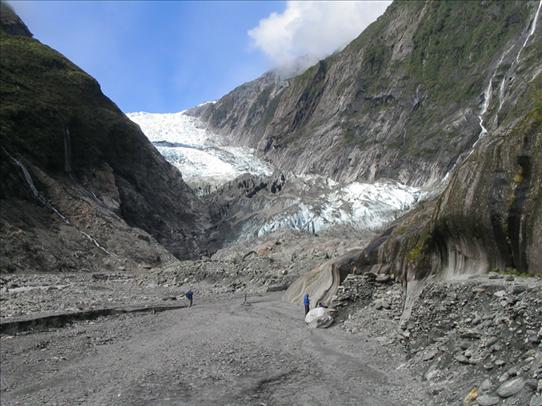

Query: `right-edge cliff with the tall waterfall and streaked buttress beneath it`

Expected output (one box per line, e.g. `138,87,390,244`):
359,2,542,281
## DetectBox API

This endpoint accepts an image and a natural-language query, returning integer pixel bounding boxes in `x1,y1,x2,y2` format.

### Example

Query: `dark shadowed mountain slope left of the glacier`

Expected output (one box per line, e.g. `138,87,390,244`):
0,3,207,270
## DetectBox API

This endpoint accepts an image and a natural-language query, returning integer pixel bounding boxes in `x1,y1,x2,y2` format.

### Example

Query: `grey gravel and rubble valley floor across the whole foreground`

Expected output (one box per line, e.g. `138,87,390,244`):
1,256,542,406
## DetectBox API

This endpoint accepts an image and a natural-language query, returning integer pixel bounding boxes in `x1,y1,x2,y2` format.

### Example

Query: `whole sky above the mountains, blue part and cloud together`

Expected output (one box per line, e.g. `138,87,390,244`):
9,0,390,113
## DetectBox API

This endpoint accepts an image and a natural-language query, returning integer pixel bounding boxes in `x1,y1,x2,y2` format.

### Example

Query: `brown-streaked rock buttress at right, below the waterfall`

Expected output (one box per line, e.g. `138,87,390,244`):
358,87,542,281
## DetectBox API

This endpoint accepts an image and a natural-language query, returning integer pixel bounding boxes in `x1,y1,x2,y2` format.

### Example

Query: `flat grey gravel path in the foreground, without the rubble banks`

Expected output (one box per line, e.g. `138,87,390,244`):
1,294,427,405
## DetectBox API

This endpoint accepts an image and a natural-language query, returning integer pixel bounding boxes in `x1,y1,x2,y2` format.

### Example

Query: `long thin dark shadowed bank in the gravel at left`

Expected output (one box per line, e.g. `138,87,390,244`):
0,304,186,335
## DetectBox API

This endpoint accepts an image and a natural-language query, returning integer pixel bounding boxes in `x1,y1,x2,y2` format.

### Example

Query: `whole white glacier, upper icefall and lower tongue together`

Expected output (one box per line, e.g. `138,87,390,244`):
127,111,424,240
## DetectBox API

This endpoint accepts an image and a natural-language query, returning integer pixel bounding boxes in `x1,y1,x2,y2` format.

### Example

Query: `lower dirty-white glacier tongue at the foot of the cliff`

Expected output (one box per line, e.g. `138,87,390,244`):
239,175,424,240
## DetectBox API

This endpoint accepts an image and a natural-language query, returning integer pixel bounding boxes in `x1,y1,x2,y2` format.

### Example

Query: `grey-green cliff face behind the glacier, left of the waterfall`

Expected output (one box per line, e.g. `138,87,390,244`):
192,1,537,185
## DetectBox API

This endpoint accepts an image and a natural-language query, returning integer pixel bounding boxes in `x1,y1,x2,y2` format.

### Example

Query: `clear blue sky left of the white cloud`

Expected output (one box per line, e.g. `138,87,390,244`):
10,1,285,112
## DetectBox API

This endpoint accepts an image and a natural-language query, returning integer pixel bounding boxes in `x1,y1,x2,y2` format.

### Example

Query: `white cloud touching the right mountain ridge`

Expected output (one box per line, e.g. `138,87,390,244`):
248,1,391,73
